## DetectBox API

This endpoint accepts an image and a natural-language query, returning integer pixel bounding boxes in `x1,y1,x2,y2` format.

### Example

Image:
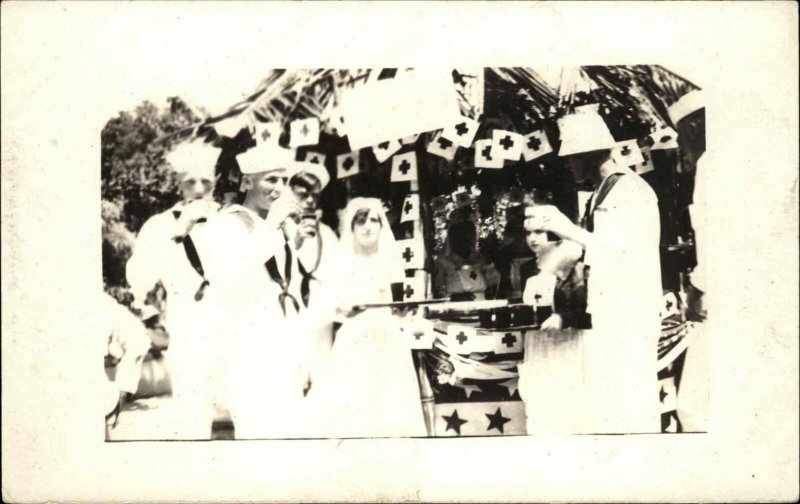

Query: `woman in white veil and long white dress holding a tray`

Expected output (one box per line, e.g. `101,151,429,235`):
309,198,427,437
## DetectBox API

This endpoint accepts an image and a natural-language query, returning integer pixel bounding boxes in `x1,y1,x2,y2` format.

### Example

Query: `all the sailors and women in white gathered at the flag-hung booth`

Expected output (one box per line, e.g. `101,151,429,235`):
101,96,708,439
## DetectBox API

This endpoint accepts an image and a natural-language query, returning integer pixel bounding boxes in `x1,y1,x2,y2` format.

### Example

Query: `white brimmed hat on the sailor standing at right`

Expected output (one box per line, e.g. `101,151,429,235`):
557,104,617,156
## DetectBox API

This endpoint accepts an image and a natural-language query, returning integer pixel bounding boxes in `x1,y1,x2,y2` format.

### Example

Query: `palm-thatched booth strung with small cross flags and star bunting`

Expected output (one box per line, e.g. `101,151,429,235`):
167,66,704,436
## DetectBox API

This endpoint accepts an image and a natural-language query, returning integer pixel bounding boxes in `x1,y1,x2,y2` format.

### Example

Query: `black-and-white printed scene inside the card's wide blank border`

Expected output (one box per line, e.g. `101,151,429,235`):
101,65,708,441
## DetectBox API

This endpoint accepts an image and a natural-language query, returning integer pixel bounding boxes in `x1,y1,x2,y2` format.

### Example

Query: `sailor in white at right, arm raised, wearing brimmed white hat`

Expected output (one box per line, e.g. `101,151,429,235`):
540,106,662,432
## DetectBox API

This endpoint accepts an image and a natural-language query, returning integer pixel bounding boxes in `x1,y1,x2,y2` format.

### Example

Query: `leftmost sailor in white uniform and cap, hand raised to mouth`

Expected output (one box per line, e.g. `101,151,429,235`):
126,142,219,439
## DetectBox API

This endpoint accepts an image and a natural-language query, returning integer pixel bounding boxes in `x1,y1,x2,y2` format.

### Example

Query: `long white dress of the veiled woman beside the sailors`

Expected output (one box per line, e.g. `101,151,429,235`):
309,253,427,437
